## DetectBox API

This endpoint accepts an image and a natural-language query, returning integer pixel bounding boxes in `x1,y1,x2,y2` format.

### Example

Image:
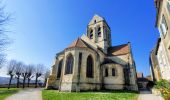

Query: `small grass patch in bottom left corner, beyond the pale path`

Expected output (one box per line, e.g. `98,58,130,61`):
0,88,19,100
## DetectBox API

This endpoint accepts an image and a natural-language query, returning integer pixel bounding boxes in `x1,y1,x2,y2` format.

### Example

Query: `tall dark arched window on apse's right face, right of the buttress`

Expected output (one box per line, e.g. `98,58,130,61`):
86,56,93,78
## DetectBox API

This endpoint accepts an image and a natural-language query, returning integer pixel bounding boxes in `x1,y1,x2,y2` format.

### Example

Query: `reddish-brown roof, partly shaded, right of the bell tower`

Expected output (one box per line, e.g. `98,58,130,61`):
108,44,130,56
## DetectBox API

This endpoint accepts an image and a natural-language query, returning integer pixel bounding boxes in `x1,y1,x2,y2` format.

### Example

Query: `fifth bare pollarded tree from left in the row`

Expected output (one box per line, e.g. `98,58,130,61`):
35,64,45,88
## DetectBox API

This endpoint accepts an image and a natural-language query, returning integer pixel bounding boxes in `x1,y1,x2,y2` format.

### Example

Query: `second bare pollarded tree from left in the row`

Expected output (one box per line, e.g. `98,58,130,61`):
14,62,23,88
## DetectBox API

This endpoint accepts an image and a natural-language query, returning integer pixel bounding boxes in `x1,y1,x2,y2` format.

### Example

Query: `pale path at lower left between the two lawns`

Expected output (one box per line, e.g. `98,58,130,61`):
5,88,42,100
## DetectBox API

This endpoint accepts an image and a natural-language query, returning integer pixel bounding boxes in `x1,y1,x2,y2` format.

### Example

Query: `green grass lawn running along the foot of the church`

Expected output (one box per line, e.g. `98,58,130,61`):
42,90,138,100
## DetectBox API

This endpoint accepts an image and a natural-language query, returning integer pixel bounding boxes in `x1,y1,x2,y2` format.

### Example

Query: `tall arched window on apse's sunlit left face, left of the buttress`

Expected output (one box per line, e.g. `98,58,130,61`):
65,54,74,74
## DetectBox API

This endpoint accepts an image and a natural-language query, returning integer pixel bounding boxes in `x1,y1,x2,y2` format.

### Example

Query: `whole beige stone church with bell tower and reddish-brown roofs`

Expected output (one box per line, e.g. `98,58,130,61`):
46,15,138,92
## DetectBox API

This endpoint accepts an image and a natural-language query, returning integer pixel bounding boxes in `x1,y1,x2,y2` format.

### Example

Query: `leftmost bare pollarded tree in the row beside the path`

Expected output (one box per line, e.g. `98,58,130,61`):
7,60,17,89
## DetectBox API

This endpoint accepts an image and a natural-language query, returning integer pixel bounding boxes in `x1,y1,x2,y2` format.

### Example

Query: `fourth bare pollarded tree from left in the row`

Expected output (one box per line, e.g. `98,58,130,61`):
26,65,35,87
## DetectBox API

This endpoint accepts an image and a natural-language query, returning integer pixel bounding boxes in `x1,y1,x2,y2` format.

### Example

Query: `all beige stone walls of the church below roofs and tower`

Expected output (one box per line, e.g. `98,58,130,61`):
48,43,137,92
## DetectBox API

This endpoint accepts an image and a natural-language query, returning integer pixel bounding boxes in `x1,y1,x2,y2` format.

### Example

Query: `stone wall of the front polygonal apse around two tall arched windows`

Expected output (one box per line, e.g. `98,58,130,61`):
61,48,101,91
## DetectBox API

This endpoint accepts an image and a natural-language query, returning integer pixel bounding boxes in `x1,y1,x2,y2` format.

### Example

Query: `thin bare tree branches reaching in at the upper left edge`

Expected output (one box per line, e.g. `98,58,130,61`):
0,2,10,68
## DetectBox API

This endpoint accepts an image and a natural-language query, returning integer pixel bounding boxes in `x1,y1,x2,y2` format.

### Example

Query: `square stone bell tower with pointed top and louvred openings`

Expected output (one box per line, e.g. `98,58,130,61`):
87,15,111,53
